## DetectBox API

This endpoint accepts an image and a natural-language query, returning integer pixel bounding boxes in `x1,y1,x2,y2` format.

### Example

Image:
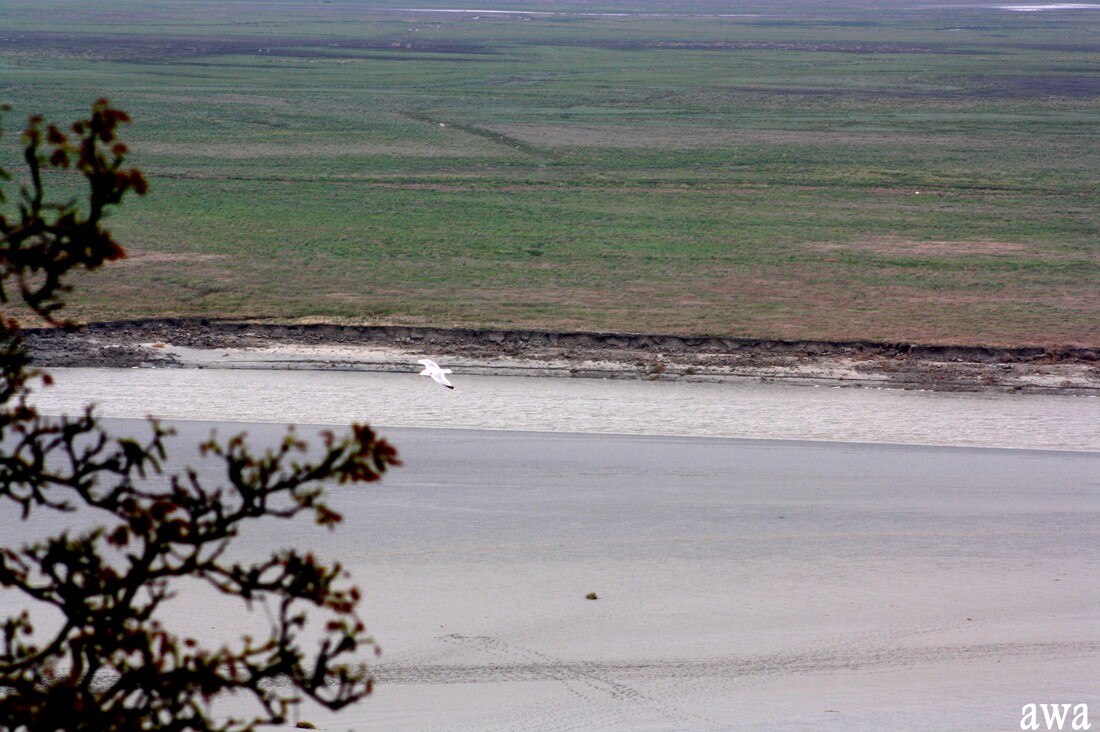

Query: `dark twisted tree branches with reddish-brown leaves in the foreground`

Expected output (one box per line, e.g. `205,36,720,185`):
0,99,399,732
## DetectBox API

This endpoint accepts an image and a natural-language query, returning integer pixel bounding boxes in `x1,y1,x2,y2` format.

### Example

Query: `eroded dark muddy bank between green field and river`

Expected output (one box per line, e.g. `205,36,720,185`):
23,318,1100,395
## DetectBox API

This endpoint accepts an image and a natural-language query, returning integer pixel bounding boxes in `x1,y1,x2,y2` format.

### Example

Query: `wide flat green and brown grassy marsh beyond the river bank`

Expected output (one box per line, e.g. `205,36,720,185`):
0,0,1100,346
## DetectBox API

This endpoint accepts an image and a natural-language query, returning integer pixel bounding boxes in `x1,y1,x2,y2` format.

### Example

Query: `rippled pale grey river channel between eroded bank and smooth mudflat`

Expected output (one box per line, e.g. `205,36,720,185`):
25,369,1100,451
